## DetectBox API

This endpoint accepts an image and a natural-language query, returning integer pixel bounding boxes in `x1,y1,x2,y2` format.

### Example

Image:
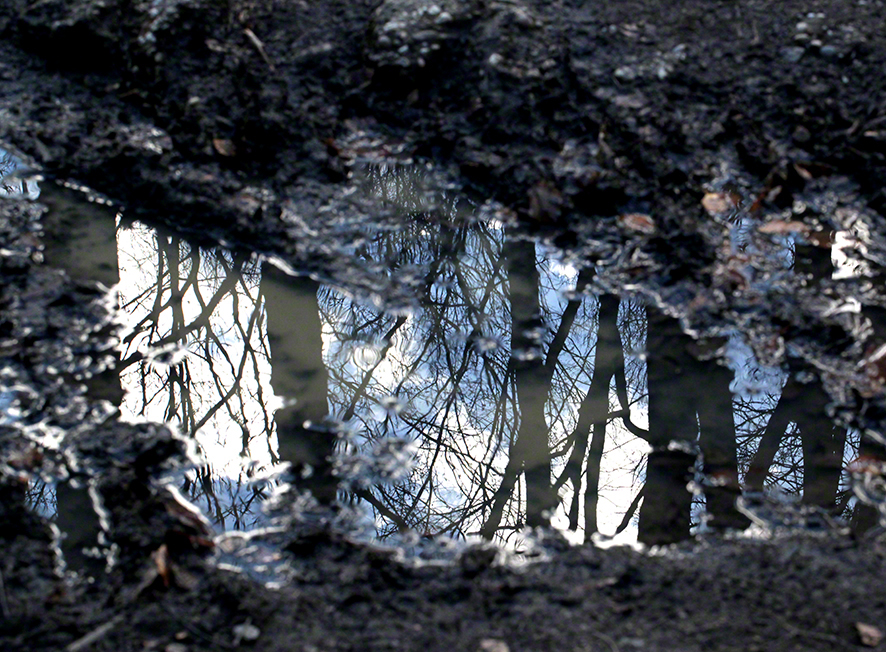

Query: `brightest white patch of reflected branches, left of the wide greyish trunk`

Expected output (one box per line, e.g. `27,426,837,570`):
119,227,276,527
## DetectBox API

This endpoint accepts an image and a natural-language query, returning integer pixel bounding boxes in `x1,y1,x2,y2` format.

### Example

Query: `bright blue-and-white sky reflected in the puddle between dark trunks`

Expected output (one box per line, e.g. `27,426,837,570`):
102,170,852,545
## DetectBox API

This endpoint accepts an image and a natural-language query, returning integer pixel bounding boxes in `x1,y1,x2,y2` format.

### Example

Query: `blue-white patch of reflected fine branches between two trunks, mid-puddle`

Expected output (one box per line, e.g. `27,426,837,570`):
320,215,515,533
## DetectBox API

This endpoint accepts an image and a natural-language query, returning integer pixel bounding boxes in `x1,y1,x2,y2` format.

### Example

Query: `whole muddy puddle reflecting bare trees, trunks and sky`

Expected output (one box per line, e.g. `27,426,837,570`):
4,155,876,580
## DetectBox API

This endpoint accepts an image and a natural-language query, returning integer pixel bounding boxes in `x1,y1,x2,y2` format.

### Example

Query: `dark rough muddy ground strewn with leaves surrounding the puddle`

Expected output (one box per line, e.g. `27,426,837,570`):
0,0,886,652
